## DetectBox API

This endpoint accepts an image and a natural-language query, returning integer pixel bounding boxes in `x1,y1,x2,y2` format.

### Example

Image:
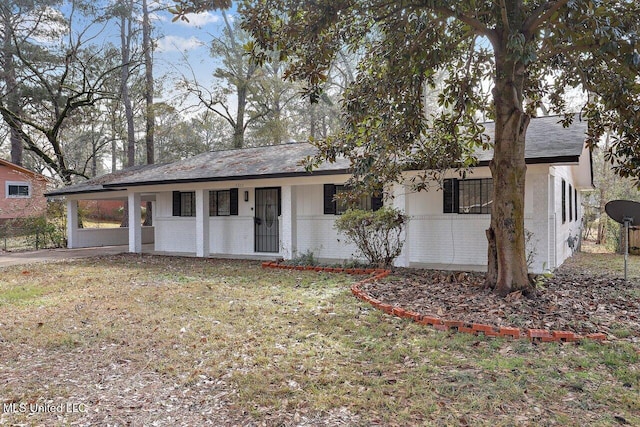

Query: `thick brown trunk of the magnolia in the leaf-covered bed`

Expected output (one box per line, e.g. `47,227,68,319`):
487,53,532,296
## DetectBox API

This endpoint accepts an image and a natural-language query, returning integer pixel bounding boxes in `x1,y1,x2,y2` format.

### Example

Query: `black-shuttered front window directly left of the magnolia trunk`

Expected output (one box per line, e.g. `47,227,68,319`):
443,178,493,214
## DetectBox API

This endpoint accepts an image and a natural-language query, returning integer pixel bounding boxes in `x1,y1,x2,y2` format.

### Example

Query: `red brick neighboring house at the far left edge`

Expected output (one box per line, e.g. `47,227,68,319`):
0,159,48,221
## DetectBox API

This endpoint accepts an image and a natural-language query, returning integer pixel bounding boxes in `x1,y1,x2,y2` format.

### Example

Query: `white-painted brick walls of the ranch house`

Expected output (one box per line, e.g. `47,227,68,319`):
146,165,581,272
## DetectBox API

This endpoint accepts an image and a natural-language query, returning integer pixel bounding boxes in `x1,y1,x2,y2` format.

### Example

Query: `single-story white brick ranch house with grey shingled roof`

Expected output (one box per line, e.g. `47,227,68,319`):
50,117,592,272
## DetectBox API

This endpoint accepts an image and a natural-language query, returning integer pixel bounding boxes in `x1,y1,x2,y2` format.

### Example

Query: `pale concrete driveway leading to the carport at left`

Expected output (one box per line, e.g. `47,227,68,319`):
0,245,129,268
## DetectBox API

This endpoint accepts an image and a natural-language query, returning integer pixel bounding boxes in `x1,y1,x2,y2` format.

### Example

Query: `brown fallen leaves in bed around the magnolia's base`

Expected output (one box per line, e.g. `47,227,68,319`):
362,263,640,342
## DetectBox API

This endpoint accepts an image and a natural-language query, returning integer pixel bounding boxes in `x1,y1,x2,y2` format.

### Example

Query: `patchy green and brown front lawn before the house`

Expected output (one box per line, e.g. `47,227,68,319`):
0,255,640,426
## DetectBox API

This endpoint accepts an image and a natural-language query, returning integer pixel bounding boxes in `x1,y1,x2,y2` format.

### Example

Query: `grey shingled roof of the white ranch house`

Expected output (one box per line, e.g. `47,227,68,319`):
48,116,587,196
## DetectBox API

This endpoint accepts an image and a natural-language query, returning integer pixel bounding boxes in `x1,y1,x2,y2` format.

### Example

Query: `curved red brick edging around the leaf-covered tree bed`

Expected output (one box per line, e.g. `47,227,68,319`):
262,262,607,342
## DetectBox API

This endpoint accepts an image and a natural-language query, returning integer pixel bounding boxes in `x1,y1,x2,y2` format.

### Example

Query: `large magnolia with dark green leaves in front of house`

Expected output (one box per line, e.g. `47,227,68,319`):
174,0,640,295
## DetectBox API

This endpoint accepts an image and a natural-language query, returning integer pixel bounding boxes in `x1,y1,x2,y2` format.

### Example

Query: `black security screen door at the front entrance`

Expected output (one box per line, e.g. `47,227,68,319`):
254,188,280,252
